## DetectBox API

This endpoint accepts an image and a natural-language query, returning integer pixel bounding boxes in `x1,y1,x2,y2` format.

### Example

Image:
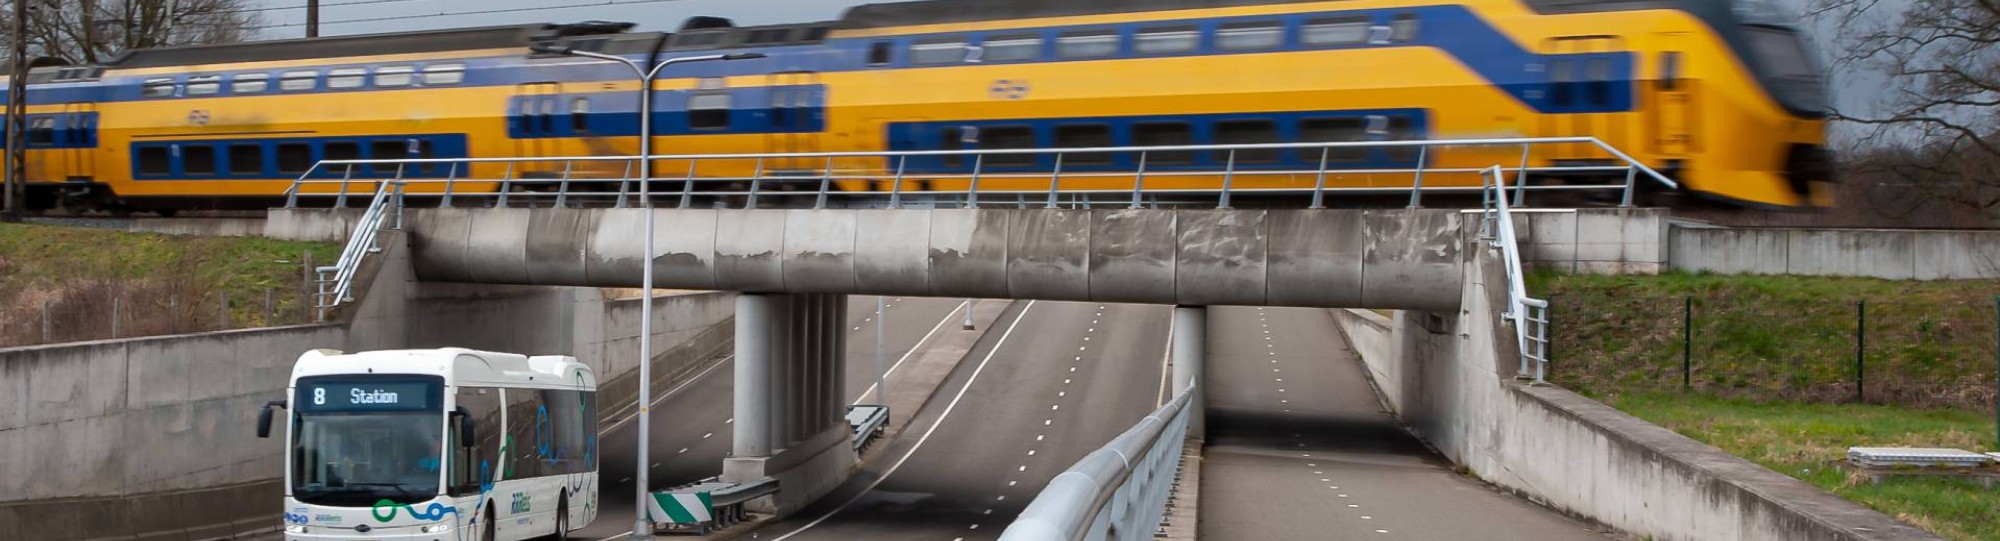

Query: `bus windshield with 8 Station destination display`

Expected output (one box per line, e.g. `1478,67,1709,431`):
290,381,444,507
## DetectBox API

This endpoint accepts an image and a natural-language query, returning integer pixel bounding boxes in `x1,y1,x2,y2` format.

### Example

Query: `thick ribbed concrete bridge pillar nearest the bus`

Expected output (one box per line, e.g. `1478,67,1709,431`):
722,293,856,515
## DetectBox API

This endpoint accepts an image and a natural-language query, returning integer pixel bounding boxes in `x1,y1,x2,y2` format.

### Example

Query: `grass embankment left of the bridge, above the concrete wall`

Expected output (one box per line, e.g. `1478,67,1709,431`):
0,224,338,347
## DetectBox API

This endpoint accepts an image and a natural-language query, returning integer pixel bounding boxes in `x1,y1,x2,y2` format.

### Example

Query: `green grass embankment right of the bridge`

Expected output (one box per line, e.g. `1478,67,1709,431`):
1530,275,2000,541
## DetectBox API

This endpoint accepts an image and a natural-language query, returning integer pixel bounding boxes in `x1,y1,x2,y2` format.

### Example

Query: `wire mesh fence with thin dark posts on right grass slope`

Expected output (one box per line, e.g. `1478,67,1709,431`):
1550,291,2000,411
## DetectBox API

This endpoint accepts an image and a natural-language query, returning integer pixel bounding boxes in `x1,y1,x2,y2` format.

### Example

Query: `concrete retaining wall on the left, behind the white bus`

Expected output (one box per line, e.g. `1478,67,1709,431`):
0,234,734,539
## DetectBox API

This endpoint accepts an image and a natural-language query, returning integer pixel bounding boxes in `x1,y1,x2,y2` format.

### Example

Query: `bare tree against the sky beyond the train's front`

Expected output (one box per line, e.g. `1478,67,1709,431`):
1814,0,2000,222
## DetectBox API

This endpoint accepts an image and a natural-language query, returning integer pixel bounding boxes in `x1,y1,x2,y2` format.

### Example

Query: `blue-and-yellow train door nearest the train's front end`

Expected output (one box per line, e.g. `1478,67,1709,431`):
1536,36,1632,162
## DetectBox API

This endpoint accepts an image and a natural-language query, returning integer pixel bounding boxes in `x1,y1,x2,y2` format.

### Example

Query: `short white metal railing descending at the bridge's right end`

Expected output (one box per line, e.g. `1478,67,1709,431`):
1480,166,1548,383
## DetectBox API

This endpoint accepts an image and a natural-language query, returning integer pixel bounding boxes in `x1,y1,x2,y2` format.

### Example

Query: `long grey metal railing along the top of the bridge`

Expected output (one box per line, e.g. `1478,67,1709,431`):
286,136,1678,208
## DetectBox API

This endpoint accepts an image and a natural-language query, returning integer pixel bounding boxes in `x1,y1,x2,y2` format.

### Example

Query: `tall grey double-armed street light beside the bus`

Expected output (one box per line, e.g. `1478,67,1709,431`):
530,44,764,539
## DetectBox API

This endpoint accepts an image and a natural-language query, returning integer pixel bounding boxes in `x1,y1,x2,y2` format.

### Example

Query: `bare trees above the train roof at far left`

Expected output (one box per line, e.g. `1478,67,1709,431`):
0,0,258,64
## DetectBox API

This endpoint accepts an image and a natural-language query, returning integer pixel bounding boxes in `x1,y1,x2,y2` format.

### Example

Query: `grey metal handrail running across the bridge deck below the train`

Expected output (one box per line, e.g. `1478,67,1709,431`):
286,136,1680,208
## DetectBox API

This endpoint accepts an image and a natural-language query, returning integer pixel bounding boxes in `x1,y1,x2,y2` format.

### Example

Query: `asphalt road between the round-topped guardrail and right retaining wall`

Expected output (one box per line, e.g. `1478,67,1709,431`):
1198,309,1610,541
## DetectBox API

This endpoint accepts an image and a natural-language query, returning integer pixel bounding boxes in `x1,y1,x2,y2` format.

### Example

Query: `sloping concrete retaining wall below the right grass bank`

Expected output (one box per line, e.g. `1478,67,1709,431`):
1336,220,1936,541
